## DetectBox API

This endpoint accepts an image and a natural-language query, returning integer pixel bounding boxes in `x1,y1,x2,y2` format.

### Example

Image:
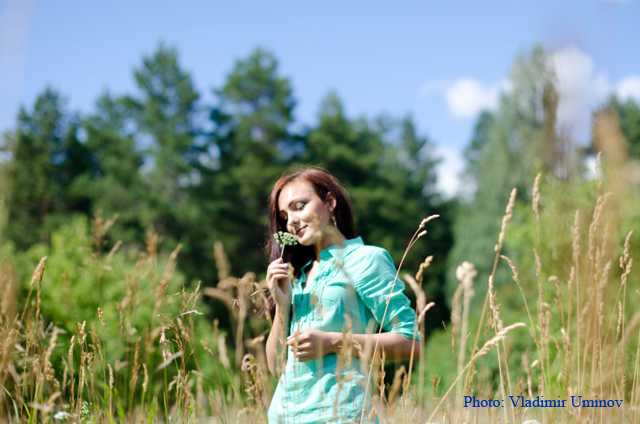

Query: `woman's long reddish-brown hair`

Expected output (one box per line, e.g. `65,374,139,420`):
265,166,358,316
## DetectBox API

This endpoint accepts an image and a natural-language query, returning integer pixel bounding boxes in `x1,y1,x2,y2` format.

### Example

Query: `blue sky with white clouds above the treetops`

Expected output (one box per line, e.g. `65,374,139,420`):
0,0,640,193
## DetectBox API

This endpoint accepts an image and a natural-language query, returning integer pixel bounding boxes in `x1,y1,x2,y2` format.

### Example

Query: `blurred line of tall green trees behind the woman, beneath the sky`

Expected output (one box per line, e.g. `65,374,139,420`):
0,44,640,329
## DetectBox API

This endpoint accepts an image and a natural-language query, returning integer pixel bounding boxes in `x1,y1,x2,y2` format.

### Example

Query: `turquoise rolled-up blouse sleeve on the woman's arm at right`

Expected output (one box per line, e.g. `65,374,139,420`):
355,246,420,340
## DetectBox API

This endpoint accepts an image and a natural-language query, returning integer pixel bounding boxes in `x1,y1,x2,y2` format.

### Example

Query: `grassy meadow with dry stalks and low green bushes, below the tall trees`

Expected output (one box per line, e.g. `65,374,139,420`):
0,152,640,423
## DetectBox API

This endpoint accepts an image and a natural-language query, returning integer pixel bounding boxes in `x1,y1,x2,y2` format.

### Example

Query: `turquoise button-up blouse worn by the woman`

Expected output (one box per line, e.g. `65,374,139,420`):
268,237,419,424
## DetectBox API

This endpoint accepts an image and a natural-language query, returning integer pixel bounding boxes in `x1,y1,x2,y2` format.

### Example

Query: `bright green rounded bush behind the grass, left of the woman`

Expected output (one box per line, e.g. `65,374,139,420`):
17,215,220,406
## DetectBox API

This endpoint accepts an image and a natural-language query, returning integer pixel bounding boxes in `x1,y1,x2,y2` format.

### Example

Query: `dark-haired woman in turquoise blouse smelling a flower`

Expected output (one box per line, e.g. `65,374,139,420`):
266,167,420,423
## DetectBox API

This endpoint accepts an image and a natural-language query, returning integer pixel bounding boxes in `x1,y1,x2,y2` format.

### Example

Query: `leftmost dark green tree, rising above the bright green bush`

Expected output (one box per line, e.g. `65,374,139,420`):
5,88,91,249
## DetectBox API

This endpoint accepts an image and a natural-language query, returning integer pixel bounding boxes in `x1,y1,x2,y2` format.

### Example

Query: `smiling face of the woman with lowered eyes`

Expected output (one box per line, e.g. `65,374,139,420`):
278,179,335,246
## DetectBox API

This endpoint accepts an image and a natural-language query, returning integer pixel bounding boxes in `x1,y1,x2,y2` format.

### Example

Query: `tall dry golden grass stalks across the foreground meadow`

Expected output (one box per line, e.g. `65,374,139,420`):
0,117,640,423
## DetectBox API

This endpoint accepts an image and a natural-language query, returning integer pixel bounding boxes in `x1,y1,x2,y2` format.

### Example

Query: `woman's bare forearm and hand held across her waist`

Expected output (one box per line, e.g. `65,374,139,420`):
288,329,421,362
